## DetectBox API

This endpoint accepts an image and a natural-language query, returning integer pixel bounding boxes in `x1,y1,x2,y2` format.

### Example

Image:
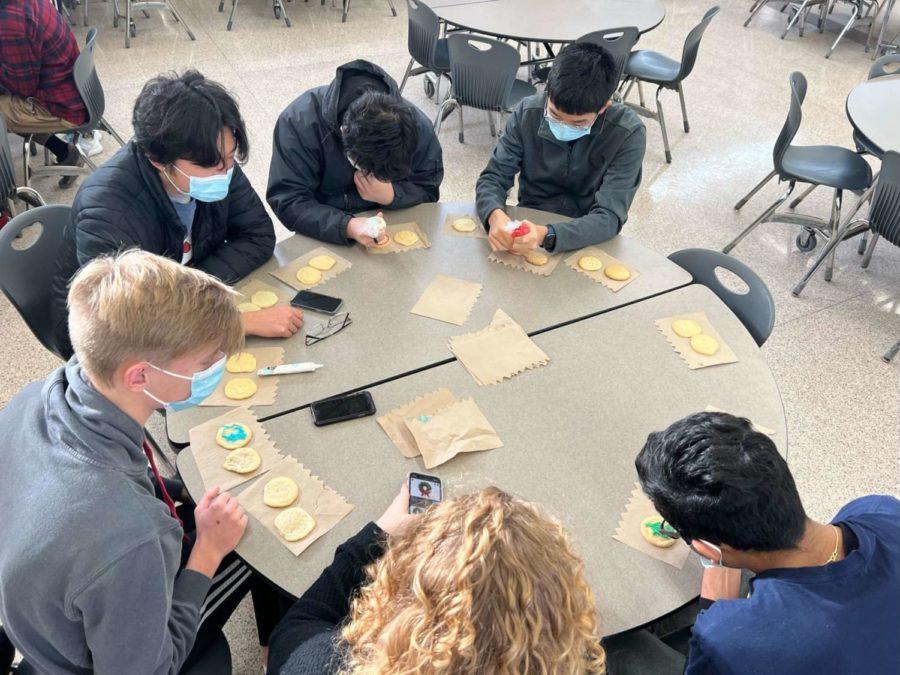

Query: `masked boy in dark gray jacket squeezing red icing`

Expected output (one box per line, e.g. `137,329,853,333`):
475,42,646,255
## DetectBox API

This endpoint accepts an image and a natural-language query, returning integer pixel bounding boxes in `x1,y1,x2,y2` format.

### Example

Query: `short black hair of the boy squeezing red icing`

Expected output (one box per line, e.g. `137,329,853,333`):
547,42,619,115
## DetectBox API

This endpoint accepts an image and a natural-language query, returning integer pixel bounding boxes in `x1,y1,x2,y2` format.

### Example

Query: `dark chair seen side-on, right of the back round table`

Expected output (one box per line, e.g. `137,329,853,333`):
622,6,719,163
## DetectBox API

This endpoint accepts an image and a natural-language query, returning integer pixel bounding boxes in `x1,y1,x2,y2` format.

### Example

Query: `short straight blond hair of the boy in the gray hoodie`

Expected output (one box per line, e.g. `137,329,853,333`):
68,250,244,385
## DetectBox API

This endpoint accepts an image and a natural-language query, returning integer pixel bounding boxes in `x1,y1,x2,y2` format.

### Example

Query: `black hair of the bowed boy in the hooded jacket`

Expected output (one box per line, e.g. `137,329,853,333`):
341,92,419,182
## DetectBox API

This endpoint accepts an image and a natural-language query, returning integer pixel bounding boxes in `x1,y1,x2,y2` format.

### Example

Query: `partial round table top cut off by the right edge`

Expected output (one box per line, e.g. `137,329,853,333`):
847,73,900,153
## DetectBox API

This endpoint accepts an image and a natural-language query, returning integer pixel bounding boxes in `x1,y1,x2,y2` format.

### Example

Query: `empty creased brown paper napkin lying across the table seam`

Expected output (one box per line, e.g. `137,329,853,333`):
449,309,550,385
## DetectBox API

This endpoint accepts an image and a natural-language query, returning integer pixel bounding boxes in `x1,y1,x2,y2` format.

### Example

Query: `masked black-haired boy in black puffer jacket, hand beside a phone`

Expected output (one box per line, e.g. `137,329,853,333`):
54,70,303,354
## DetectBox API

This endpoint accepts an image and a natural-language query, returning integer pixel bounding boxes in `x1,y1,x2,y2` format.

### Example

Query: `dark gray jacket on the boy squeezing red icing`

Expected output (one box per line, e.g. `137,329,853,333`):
475,94,647,251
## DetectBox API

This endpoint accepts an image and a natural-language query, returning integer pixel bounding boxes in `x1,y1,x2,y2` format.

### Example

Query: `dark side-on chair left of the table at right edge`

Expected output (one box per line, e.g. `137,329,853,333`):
722,72,872,280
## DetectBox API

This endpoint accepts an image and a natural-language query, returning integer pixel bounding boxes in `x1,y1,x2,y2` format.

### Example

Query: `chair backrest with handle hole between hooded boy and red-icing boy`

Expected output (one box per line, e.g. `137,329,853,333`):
447,33,520,111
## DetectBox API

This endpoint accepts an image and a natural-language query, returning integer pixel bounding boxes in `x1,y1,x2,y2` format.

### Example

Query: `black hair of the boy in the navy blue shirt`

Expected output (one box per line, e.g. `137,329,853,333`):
635,413,806,551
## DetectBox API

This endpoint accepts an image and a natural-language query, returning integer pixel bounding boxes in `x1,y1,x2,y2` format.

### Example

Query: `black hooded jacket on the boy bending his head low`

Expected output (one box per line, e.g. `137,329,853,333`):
266,60,444,244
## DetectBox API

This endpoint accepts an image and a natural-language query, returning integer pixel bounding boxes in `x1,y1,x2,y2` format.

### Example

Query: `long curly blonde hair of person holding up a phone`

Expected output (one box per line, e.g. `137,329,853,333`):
341,487,606,675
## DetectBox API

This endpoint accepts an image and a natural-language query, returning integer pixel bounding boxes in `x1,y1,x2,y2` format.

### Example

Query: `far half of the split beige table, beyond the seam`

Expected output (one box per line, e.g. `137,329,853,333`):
167,202,691,445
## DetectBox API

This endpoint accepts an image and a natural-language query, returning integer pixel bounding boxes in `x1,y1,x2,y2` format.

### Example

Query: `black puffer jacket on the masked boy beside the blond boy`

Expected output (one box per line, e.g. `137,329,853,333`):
53,142,275,356
